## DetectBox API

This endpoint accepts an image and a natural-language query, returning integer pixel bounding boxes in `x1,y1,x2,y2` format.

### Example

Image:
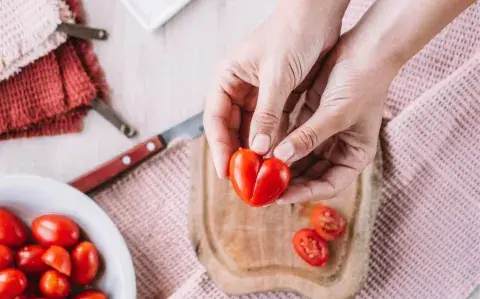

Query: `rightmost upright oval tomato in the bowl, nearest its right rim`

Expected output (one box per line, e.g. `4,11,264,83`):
72,242,99,285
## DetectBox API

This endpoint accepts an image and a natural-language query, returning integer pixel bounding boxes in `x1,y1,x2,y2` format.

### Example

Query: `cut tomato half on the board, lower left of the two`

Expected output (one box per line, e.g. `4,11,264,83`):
293,228,329,267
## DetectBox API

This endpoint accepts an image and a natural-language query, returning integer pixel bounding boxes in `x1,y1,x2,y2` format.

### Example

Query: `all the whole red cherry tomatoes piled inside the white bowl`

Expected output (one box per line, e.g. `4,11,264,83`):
0,208,107,299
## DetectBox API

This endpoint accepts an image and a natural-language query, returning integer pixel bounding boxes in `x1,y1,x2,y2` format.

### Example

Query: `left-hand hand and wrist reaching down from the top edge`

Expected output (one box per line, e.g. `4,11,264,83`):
204,0,348,178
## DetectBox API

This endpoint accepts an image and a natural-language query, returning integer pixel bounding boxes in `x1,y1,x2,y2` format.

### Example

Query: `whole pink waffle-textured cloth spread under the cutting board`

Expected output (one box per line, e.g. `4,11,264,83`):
94,0,480,299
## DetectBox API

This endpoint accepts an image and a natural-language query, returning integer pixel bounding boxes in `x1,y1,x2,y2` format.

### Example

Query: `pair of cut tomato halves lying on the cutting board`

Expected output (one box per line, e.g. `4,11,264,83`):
293,205,346,267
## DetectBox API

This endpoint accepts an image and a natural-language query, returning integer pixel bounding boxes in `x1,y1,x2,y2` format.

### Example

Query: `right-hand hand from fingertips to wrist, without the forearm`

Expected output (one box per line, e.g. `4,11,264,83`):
273,34,399,204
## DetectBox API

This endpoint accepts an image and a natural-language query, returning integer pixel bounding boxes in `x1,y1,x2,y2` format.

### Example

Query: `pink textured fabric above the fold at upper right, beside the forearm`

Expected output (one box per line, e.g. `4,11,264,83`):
342,0,480,119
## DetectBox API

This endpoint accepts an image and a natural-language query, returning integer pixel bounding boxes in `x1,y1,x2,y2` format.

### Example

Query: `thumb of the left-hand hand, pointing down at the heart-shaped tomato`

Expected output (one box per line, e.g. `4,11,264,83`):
249,70,292,155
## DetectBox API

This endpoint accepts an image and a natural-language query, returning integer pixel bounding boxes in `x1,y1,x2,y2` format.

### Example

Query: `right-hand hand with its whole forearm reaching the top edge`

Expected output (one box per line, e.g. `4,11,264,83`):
274,0,474,204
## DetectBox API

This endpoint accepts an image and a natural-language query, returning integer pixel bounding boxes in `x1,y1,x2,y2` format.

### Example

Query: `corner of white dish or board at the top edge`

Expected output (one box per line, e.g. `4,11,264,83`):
122,0,191,31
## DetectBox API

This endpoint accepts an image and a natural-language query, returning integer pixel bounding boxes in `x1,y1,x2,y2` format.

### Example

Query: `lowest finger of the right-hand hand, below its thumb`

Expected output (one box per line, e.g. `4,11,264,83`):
277,160,360,205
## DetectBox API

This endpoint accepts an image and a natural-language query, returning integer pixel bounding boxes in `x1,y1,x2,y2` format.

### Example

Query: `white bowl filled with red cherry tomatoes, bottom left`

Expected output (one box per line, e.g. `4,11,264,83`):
0,175,136,299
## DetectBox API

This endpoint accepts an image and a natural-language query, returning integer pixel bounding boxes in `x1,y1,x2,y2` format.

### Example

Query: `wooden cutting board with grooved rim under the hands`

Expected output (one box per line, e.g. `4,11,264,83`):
189,137,381,299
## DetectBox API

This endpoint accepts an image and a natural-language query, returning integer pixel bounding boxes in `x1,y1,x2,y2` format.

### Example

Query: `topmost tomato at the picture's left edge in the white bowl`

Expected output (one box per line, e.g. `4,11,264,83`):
0,209,27,247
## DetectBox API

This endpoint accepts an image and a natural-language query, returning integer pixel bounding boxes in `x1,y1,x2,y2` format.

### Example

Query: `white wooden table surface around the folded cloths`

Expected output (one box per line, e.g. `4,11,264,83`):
0,0,480,299
